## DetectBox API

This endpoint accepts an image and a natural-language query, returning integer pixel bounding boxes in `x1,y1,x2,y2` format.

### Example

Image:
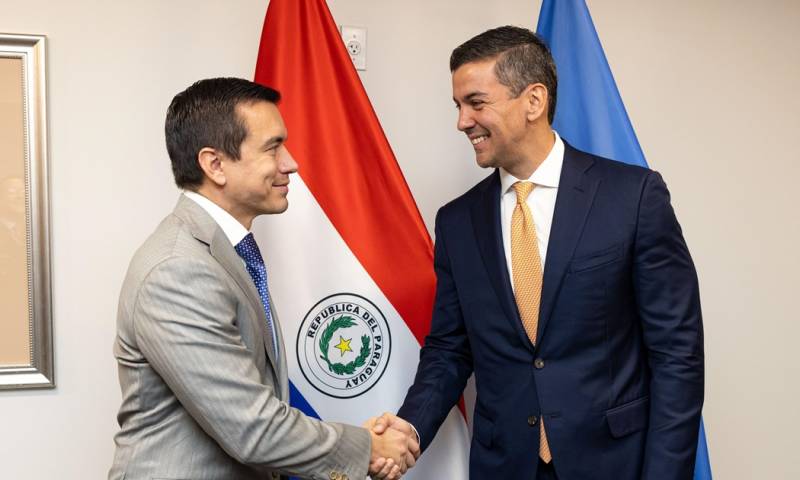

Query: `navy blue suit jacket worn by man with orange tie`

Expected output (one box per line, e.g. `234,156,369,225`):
399,144,704,480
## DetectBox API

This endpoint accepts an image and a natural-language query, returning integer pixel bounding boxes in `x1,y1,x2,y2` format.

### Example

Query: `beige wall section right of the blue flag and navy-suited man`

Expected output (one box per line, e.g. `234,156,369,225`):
590,0,800,479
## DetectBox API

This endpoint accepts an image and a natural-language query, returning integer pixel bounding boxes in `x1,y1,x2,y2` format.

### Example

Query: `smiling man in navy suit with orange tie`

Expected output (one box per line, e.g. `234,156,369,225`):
377,27,704,480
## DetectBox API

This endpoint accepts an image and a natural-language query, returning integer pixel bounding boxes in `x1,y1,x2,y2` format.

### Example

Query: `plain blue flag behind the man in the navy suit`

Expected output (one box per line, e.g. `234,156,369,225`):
536,0,711,480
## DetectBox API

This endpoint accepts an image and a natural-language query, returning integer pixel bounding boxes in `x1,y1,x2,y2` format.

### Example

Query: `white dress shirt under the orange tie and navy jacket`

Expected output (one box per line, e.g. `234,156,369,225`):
499,131,564,288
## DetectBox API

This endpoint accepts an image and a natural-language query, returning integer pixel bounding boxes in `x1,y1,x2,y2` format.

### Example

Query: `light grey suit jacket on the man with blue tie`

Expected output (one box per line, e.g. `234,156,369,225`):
109,195,370,480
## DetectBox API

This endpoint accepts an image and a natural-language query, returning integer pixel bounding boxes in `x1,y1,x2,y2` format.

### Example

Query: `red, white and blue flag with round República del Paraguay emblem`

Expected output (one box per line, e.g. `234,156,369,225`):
253,0,469,479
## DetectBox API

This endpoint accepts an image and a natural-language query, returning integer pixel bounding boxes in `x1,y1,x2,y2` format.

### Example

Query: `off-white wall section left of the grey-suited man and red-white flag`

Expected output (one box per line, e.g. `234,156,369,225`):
0,0,266,480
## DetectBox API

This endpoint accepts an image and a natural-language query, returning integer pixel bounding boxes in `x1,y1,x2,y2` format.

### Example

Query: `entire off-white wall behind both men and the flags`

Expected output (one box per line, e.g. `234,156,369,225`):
0,0,800,480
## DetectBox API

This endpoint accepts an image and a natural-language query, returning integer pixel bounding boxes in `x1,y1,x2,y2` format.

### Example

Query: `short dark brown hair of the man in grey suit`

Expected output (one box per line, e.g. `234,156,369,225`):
164,78,281,189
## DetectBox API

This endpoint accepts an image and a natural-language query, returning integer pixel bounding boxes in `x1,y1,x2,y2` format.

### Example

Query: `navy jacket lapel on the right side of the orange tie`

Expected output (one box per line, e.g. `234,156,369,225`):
536,142,600,341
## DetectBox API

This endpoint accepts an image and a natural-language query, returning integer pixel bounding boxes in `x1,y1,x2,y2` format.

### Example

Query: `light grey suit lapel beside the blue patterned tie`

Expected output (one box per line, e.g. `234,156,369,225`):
174,195,279,372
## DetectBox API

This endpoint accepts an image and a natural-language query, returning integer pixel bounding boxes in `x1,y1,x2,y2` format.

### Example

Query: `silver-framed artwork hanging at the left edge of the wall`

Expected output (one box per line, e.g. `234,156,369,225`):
0,34,55,389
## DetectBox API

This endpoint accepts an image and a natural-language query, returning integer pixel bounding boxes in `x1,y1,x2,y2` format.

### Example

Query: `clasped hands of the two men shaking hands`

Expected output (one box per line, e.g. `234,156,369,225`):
364,413,420,480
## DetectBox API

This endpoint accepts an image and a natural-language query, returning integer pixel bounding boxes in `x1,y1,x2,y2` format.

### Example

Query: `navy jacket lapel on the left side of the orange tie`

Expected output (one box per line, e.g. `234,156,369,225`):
471,170,533,348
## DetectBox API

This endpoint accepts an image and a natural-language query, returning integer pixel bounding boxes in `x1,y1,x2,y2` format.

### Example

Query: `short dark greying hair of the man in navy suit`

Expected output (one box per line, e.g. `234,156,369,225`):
450,25,558,124
